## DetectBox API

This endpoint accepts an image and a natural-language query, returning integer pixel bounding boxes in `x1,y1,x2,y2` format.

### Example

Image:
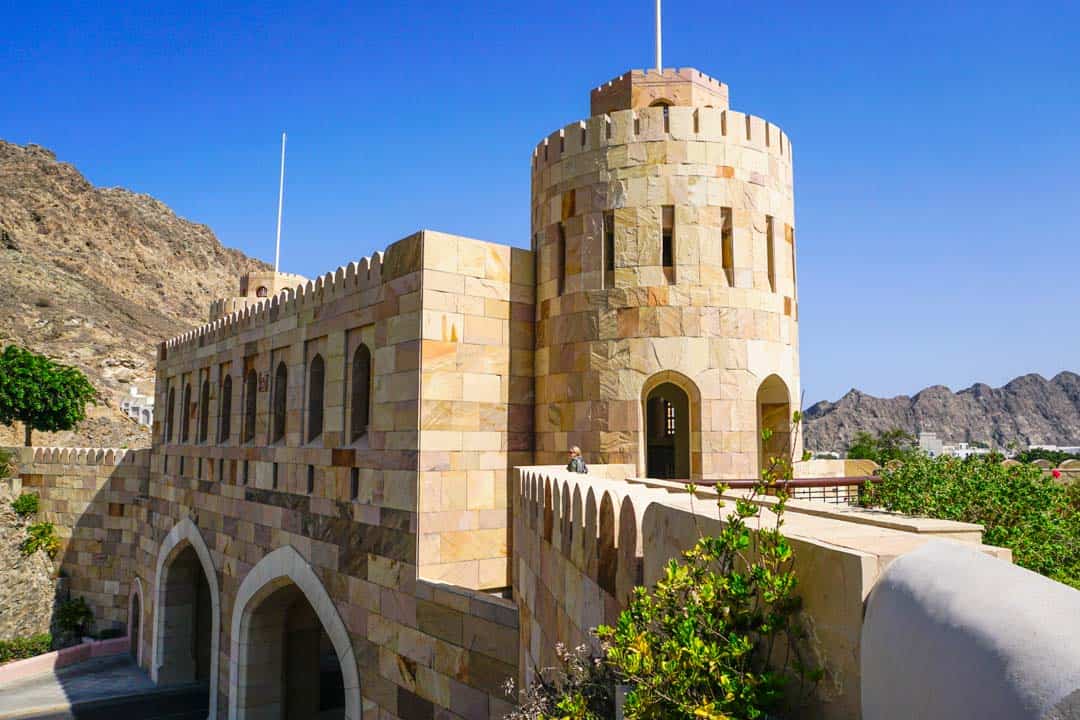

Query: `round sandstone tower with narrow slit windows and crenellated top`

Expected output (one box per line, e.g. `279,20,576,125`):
531,68,801,479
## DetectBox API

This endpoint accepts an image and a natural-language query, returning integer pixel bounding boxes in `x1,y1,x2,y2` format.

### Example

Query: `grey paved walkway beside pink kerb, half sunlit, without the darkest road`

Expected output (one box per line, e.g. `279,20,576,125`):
0,655,190,720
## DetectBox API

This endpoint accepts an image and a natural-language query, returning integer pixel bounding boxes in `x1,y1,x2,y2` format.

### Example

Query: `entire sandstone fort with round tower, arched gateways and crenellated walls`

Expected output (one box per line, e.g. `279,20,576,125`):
12,69,881,720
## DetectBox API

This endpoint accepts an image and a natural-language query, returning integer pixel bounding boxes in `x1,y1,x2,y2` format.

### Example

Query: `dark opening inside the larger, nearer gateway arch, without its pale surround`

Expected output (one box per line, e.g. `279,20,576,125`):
239,583,346,720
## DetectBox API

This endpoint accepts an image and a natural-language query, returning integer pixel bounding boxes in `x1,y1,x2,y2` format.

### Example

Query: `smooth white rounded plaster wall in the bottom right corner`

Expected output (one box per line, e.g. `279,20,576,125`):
862,543,1080,720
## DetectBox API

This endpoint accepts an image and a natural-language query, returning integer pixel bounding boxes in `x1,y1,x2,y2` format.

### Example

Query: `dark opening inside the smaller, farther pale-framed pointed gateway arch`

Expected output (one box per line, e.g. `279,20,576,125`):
158,543,214,685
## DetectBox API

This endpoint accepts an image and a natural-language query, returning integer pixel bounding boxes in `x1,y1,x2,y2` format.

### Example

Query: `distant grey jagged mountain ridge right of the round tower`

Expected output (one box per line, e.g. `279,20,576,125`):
804,372,1080,451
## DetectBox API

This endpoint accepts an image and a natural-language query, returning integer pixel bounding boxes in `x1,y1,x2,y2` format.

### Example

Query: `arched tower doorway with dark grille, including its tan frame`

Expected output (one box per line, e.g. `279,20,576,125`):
638,370,701,479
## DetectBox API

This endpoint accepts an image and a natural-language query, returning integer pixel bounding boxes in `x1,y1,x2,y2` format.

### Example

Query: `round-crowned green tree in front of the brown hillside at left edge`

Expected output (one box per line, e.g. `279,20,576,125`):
0,345,97,447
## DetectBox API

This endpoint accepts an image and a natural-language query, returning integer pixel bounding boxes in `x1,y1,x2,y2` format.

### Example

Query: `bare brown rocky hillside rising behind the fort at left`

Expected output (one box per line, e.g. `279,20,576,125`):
0,140,268,447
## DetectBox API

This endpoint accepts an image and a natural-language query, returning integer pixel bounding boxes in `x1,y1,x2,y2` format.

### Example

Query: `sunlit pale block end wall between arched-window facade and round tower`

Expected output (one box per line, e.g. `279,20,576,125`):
418,231,535,588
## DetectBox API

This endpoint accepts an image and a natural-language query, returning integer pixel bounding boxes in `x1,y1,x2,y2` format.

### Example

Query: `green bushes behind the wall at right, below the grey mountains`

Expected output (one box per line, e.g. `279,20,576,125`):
863,456,1080,588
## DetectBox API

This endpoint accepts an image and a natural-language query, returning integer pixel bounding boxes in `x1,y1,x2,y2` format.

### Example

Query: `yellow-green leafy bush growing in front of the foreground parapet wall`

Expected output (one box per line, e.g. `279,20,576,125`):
509,413,821,720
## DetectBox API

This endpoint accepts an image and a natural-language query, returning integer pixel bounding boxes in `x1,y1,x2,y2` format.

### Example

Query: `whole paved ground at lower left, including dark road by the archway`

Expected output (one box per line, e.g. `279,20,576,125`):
0,655,207,720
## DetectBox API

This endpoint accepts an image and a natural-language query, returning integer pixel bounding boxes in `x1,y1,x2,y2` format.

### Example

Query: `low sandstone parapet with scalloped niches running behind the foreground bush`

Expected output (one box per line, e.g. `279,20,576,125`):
513,466,1008,719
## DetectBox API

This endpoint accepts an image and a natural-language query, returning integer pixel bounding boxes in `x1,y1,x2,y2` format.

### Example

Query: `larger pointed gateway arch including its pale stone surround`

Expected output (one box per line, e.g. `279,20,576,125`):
229,546,361,720
